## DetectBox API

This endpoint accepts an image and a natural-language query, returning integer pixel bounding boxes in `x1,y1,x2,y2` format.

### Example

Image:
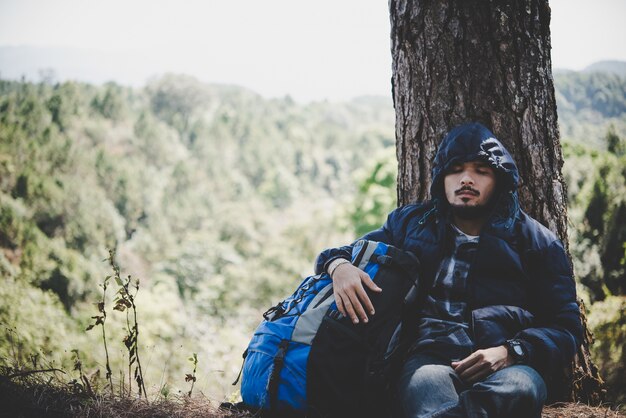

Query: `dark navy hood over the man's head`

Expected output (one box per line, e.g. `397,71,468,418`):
430,122,519,228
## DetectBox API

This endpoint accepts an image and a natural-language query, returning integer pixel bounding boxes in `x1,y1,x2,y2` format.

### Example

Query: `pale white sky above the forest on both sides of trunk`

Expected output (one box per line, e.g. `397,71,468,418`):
0,0,626,101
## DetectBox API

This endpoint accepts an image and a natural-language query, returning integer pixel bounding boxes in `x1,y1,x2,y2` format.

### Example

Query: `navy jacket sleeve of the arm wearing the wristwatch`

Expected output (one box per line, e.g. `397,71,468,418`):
515,239,583,379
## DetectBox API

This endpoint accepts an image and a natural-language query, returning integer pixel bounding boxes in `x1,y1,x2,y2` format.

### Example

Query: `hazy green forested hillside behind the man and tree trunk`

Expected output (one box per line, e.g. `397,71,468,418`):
0,71,626,404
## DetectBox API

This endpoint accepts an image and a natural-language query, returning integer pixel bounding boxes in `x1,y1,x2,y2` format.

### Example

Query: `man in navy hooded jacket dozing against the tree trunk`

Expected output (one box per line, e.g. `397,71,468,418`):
316,123,582,418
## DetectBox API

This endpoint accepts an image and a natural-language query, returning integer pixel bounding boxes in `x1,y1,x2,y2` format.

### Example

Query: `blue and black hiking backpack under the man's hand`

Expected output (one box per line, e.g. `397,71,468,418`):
236,240,424,417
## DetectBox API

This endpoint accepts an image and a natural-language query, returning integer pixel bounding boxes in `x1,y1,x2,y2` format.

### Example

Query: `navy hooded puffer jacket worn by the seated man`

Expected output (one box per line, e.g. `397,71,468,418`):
316,123,582,395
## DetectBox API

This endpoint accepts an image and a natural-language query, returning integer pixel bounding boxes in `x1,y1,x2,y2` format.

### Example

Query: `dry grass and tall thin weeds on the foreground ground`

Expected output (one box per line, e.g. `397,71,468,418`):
0,251,626,418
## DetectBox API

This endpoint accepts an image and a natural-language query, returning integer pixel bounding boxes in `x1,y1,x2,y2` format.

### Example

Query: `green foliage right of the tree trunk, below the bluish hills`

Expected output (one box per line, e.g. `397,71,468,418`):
563,128,626,405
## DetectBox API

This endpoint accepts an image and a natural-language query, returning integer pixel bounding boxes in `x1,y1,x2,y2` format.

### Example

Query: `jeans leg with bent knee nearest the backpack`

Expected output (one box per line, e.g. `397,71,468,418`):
397,353,461,418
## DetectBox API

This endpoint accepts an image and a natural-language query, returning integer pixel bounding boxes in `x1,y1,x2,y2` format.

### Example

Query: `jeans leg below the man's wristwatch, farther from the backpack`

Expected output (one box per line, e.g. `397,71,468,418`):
434,365,546,418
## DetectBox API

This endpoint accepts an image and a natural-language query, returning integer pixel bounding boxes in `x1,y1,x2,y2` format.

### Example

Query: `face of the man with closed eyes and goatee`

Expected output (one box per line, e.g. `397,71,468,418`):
444,161,496,215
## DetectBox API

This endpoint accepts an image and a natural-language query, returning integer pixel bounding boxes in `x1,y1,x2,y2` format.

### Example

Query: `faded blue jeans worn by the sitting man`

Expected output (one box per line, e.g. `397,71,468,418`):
396,353,546,418
